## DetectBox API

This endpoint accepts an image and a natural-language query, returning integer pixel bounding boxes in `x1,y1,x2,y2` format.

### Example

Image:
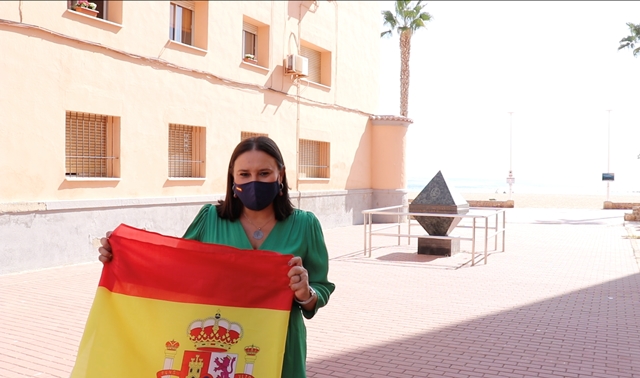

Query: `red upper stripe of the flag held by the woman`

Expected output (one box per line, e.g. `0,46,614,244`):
99,224,293,311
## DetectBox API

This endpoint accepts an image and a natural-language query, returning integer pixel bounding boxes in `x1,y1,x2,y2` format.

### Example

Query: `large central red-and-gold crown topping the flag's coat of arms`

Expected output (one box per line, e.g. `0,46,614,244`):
187,313,242,352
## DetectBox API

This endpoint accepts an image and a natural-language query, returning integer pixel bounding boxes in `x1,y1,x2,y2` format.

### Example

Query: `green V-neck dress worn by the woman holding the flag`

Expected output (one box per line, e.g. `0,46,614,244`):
184,204,335,378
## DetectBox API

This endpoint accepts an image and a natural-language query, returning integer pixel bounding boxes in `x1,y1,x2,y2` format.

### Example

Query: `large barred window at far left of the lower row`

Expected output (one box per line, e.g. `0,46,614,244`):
65,112,120,177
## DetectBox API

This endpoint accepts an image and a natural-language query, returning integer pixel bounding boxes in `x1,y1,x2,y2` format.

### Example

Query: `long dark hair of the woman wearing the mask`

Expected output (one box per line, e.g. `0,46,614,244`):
217,136,293,221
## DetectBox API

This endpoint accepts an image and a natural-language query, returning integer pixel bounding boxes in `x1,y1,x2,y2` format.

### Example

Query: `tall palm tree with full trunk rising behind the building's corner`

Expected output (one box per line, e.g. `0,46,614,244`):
380,0,431,117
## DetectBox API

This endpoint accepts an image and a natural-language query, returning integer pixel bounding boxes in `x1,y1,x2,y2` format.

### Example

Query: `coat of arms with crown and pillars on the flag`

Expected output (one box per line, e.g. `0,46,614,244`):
156,312,260,378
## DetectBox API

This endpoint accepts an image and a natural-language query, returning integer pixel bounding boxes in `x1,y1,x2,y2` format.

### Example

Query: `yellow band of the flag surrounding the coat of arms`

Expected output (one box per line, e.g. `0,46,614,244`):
71,288,289,378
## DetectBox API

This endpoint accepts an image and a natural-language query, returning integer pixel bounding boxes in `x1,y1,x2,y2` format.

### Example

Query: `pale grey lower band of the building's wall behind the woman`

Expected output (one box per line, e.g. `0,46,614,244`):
0,189,376,275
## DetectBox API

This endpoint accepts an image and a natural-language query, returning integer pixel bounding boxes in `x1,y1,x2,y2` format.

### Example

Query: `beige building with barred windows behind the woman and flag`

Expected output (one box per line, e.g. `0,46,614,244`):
0,1,411,274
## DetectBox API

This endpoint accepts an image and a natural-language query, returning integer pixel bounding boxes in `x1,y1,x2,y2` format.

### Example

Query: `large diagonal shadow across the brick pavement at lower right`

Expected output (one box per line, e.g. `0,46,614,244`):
307,274,640,378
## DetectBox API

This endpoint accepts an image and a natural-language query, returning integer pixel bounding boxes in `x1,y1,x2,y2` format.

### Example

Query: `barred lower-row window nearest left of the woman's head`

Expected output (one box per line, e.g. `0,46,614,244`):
169,124,206,177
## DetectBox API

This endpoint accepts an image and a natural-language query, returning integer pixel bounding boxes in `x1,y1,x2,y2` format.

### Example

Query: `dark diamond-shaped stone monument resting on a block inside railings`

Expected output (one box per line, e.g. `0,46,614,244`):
409,171,469,236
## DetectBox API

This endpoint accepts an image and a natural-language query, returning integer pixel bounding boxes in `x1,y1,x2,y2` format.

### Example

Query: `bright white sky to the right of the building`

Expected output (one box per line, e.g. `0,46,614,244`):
378,1,640,194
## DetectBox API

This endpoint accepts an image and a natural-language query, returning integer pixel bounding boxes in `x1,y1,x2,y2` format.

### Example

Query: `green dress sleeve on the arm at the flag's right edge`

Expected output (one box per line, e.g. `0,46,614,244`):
302,212,335,319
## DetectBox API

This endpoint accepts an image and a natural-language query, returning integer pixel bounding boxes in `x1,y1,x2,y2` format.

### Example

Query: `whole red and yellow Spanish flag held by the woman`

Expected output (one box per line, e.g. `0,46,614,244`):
71,225,293,378
